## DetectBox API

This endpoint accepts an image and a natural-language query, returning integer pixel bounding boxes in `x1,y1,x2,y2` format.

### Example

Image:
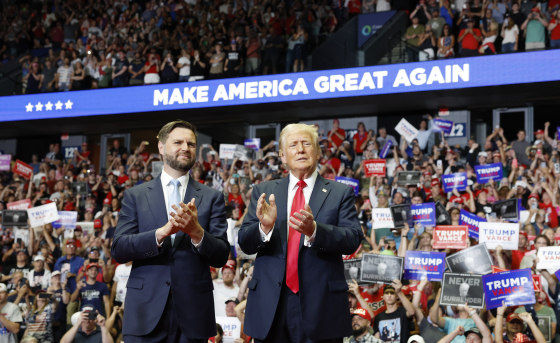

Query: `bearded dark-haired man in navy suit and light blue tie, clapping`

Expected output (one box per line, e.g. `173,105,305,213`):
111,120,229,343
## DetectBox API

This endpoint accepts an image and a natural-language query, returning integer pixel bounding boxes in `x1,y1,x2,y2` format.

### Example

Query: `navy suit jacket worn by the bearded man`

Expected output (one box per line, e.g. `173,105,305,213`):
111,177,230,339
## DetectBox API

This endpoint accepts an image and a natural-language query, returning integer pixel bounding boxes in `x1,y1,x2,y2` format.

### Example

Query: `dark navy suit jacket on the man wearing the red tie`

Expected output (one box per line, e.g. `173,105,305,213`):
239,176,363,340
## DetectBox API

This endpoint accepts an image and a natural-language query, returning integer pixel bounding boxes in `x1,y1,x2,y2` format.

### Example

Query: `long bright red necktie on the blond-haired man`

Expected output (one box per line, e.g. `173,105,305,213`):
286,180,307,293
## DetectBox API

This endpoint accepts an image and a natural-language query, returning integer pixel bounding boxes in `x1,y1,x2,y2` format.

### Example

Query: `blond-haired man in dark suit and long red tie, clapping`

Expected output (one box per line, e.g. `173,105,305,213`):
239,124,363,343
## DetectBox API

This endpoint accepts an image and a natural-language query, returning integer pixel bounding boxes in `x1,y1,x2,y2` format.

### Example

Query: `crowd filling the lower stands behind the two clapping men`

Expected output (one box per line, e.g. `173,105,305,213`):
0,117,560,343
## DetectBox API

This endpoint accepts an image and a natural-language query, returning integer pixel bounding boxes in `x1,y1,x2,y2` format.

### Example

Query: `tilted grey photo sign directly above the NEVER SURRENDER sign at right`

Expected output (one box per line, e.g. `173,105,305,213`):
445,243,492,275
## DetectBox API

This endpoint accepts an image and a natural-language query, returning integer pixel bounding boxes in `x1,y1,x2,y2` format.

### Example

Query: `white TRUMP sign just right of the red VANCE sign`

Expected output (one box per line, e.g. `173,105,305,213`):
478,222,519,250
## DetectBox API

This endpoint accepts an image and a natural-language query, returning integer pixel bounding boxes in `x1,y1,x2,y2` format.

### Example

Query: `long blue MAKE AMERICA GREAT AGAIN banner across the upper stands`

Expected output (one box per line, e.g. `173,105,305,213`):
0,49,560,123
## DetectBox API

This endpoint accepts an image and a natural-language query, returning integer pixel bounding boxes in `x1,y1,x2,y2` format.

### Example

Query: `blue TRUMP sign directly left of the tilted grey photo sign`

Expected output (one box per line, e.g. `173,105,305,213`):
404,250,445,281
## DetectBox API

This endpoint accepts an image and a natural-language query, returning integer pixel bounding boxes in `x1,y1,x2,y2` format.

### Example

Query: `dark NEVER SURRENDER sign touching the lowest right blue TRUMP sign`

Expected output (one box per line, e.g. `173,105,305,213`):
439,273,484,308
